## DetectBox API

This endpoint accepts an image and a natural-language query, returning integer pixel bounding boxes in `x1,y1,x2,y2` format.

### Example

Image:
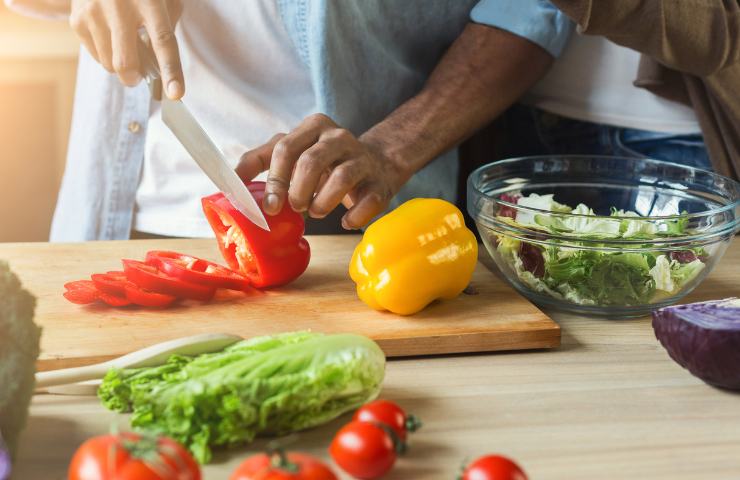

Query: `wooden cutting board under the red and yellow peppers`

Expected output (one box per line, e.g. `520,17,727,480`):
0,235,560,370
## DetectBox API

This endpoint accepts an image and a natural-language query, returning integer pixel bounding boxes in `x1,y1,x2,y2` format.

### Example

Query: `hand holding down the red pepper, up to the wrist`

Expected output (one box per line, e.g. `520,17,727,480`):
236,114,411,229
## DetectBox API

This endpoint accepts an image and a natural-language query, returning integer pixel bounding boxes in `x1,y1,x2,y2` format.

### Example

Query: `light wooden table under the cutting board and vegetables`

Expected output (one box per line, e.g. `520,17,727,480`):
7,241,740,480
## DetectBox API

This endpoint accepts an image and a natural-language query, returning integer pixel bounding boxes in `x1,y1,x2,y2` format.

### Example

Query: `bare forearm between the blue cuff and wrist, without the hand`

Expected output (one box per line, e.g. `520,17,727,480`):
360,23,553,180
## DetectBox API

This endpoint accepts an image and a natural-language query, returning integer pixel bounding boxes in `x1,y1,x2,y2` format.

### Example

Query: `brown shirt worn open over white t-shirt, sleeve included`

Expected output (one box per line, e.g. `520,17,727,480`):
552,0,740,178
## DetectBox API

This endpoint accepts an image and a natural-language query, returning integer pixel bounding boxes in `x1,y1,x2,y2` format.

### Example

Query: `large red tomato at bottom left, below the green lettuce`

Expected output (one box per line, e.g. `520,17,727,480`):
67,433,201,480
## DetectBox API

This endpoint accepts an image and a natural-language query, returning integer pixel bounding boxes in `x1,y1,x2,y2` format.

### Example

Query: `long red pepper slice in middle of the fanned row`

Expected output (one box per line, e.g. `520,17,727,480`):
122,260,216,302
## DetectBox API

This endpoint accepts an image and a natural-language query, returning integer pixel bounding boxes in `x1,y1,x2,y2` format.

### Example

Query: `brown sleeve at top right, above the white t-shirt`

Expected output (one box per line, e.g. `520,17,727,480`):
552,0,740,77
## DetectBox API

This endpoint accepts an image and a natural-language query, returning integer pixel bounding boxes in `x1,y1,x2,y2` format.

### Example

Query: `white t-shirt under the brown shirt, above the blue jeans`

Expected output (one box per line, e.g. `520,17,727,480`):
524,34,700,134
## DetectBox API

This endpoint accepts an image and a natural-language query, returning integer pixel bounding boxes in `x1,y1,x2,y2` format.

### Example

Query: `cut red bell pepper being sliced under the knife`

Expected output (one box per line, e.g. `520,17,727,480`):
201,182,311,288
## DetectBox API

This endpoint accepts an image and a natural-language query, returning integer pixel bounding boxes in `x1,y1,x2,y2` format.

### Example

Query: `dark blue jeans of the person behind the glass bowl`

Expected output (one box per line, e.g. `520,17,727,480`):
503,105,712,170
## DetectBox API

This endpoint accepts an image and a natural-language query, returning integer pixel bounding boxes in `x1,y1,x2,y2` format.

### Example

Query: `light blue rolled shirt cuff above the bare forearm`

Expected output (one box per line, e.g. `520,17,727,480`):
470,0,575,58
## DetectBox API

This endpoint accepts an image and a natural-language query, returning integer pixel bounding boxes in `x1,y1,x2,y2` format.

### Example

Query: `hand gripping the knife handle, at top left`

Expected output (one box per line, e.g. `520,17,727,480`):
69,0,185,100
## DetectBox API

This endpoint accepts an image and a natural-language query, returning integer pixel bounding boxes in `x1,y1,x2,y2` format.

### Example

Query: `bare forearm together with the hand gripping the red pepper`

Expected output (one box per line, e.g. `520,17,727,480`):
237,24,552,228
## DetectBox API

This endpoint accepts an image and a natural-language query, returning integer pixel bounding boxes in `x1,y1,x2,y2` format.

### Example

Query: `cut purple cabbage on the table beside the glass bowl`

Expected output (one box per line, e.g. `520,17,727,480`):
653,298,740,390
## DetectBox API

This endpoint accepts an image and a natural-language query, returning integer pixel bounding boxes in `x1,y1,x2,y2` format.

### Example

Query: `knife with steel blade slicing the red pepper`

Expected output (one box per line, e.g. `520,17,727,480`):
138,35,270,232
